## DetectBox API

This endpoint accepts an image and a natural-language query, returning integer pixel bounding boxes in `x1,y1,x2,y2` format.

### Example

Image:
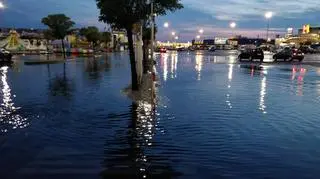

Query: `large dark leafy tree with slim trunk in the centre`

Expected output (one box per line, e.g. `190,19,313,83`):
96,0,183,90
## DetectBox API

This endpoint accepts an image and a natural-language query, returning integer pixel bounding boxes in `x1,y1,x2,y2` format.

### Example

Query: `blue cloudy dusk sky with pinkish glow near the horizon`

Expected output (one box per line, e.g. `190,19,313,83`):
0,0,320,41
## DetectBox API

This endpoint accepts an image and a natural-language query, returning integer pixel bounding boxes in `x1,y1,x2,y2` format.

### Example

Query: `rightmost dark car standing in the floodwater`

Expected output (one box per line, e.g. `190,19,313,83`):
273,48,304,62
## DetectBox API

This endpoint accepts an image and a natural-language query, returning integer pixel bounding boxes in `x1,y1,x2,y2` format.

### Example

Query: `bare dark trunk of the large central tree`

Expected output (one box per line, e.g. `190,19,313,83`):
126,28,139,91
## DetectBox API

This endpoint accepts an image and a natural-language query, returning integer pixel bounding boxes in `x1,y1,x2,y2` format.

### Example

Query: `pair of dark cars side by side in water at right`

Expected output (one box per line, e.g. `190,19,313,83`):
238,47,304,62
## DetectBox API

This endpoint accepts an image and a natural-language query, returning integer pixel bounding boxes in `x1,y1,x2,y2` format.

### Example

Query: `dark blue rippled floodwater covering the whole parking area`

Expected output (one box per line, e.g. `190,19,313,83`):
0,52,320,179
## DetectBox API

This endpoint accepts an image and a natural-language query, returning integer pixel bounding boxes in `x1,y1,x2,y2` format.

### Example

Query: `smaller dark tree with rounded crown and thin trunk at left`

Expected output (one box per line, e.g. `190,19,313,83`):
41,14,75,57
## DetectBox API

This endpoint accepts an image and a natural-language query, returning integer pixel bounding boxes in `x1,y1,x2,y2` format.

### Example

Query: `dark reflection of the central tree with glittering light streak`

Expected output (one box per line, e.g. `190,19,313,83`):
101,77,177,179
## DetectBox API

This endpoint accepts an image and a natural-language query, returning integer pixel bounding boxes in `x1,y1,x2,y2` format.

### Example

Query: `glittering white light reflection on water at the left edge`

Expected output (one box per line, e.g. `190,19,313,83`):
0,66,29,133
